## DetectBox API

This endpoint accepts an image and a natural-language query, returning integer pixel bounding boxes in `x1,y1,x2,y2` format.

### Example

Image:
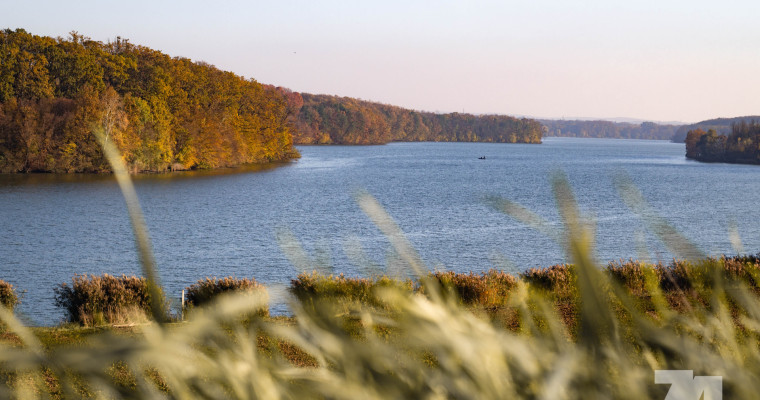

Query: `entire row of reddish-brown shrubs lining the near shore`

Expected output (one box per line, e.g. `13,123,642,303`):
0,253,760,332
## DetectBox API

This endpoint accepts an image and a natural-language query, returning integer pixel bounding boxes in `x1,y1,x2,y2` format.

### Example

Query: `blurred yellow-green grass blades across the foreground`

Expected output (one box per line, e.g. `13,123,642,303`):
0,137,760,399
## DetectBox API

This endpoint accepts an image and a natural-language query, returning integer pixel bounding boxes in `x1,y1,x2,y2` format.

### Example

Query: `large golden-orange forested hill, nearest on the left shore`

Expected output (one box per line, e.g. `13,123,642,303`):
0,29,298,172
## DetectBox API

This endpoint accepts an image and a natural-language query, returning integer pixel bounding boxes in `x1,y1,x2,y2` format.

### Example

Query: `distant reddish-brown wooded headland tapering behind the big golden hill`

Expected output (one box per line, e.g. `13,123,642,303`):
294,93,542,144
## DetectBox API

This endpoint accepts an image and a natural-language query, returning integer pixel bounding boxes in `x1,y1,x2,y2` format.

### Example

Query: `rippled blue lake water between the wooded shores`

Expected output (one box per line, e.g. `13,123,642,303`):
0,138,760,325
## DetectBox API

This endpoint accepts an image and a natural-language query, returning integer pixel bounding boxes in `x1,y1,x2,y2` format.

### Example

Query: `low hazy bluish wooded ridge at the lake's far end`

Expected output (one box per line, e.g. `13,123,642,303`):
540,120,678,140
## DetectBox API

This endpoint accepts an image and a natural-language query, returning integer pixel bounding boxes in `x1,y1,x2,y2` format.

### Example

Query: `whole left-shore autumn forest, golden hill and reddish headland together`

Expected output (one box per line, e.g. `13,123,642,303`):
0,29,542,172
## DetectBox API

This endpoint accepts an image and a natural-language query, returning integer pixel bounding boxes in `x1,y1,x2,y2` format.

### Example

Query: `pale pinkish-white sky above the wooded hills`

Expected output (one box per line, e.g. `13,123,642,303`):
0,0,760,122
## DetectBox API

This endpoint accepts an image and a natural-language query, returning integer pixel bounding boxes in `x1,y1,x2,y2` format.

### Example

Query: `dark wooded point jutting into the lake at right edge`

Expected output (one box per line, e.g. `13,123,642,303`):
686,120,760,164
